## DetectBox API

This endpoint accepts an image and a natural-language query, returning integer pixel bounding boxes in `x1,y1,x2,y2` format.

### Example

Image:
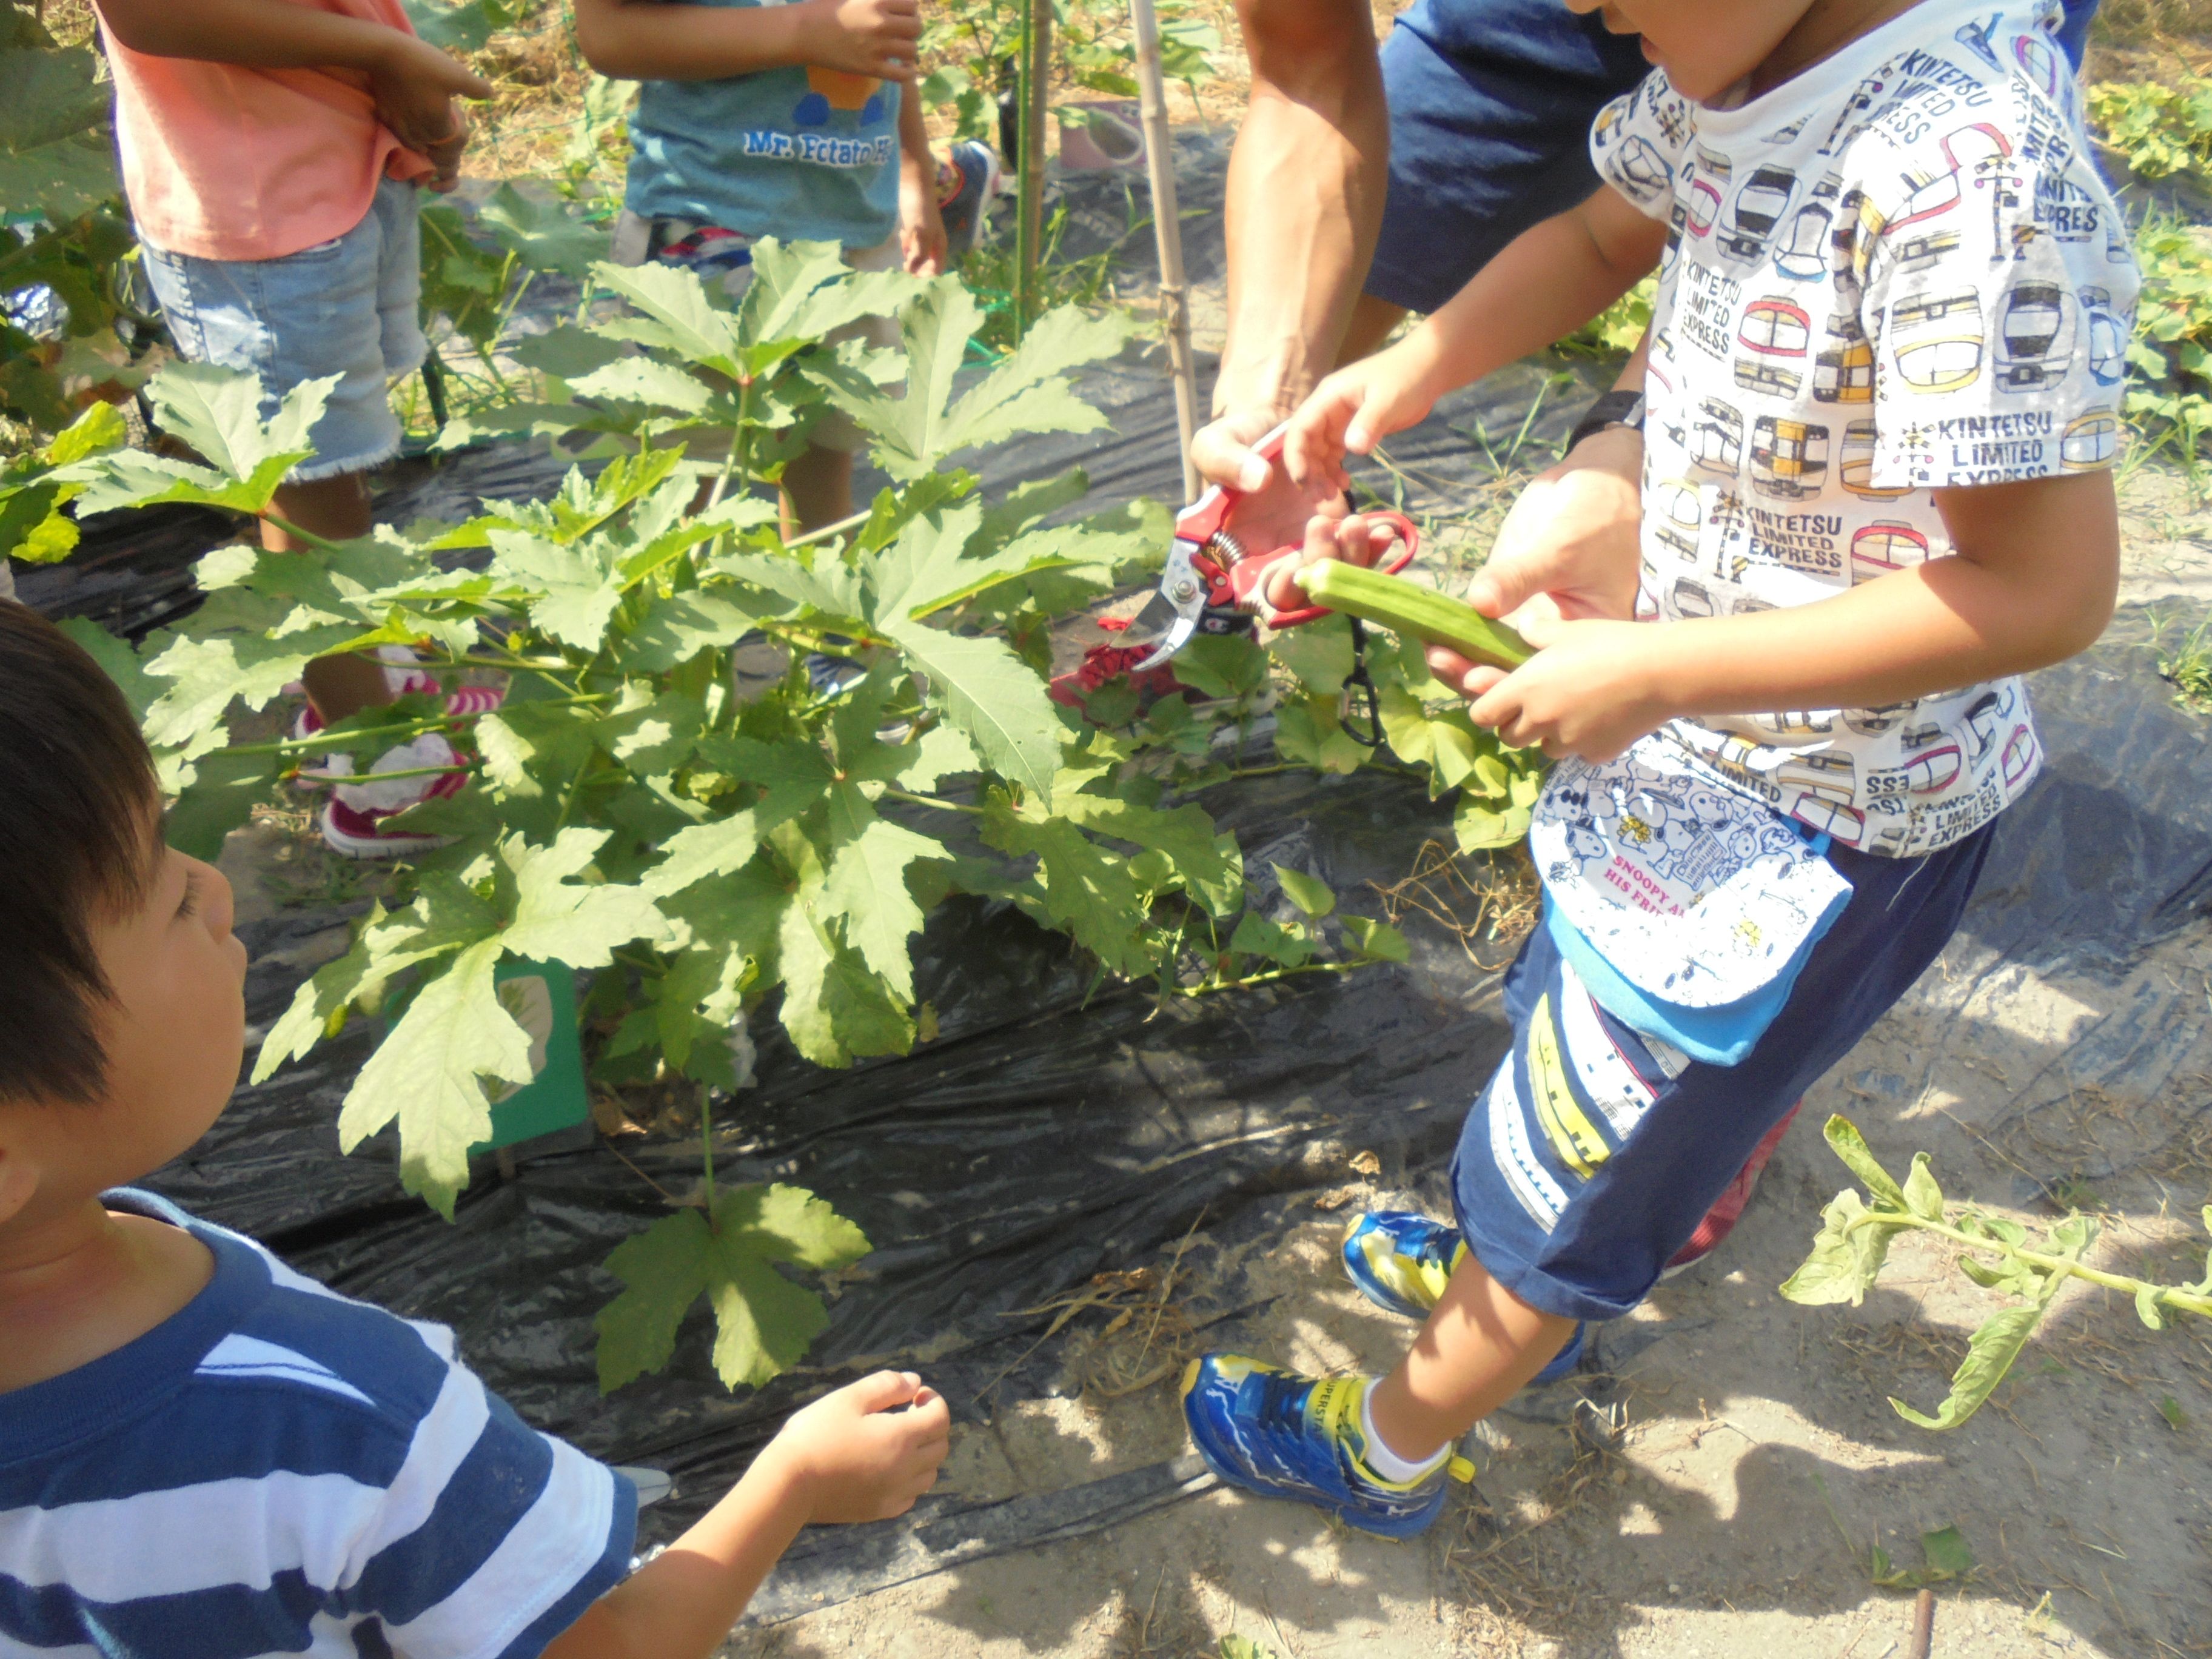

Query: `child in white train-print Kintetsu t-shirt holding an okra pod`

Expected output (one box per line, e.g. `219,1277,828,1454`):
1184,0,2137,1535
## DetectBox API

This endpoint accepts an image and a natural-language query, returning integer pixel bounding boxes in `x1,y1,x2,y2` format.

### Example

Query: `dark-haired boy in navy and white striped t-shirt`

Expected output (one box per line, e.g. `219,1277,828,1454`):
0,604,947,1659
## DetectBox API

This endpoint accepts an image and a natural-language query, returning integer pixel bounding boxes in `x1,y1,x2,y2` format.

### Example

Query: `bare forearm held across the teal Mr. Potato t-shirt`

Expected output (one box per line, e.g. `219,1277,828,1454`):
575,0,922,82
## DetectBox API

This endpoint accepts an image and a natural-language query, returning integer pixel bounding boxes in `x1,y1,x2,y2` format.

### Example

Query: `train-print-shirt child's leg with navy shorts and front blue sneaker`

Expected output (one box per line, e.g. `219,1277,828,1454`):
1184,827,1991,1537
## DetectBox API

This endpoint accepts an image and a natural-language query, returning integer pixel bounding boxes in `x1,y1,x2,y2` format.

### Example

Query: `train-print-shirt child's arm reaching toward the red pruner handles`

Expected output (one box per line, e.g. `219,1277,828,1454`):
1283,186,1666,489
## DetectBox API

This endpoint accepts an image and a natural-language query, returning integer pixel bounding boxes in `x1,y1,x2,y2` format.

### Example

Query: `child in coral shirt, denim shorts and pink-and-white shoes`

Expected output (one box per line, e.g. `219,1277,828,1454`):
98,0,491,858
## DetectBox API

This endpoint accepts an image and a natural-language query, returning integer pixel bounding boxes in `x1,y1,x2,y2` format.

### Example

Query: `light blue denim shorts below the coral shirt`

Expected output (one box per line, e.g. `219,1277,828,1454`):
146,179,429,484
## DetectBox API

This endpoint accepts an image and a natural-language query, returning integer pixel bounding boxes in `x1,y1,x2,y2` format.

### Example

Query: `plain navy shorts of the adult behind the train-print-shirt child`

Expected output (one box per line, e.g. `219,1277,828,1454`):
1367,0,2097,312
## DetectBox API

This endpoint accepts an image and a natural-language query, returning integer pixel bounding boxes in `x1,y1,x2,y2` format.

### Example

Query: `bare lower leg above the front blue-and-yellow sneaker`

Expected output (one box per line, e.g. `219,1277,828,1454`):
1367,1256,1577,1462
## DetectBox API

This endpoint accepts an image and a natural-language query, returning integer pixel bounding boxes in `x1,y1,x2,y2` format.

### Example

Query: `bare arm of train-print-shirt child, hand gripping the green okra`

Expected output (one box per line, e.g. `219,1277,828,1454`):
1429,474,2119,761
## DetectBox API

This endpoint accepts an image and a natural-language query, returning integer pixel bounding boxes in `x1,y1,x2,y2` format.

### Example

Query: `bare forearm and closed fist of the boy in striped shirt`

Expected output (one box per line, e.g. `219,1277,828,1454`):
544,1372,951,1659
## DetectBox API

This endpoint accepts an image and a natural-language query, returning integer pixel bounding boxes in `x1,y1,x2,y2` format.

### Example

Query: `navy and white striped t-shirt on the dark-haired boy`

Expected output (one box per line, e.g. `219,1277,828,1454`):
0,1192,637,1659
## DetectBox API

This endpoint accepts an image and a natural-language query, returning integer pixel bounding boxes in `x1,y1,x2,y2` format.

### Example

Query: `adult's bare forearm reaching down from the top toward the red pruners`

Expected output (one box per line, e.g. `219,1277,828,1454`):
1192,0,1389,500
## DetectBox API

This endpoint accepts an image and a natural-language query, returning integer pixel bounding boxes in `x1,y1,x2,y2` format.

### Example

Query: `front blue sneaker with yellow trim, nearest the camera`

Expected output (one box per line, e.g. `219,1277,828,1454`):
1184,1354,1475,1537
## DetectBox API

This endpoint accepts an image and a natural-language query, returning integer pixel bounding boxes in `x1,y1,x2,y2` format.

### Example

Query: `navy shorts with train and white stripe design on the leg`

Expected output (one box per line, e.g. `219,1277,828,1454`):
1451,820,2002,1318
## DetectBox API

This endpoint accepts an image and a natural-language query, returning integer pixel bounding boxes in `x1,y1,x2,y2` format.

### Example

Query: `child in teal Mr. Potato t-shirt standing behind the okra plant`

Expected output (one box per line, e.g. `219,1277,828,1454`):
575,0,945,531
